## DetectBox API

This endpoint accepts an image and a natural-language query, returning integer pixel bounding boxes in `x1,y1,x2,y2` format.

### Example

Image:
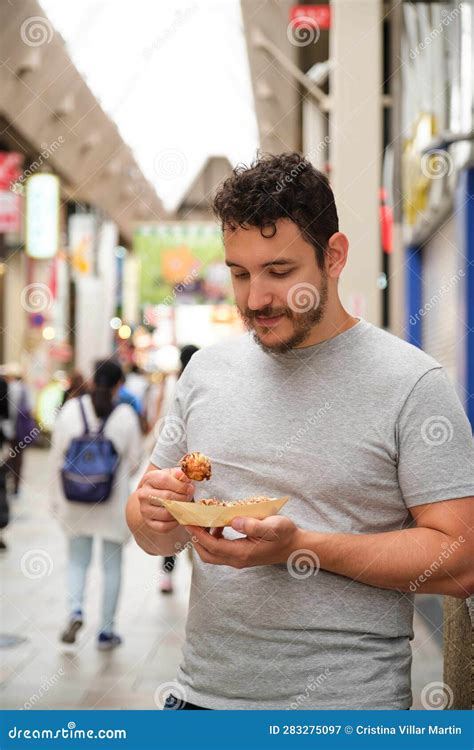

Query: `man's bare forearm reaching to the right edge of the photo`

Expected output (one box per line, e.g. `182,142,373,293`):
298,527,474,598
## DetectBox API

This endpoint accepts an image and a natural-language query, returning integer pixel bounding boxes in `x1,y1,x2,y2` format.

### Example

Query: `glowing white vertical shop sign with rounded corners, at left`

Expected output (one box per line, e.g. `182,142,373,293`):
25,174,59,260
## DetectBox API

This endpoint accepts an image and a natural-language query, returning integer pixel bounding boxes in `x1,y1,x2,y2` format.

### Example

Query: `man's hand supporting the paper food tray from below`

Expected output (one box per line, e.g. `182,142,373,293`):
186,516,300,568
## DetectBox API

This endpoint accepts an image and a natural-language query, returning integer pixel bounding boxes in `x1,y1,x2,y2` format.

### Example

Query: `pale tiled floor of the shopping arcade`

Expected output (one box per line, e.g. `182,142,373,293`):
0,449,442,709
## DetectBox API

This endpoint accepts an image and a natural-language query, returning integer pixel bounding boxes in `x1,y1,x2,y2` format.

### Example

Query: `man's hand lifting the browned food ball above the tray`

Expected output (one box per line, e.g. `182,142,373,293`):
137,467,194,534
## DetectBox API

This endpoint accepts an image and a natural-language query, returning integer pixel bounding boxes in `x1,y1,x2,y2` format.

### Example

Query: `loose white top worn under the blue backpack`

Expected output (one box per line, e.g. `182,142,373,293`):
50,396,142,542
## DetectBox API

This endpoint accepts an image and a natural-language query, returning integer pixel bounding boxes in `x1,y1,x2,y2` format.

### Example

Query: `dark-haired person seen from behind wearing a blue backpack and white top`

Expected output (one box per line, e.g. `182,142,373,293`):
51,361,142,650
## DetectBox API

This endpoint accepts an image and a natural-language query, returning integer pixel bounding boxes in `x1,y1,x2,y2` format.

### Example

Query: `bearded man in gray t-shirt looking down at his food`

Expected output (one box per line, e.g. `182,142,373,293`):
128,154,474,709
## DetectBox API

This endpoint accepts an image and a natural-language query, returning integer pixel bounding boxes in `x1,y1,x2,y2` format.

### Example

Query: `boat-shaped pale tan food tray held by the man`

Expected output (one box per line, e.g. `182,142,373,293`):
160,497,289,528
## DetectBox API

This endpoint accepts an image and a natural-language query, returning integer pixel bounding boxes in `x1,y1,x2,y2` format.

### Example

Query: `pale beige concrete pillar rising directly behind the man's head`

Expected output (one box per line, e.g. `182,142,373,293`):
330,0,383,325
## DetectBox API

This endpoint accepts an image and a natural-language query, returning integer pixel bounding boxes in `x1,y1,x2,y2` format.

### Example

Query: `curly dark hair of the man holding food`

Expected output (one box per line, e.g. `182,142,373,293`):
212,152,339,268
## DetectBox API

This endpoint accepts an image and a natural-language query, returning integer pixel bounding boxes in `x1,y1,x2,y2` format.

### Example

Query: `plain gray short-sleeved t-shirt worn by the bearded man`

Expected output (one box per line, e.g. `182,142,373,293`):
151,320,474,709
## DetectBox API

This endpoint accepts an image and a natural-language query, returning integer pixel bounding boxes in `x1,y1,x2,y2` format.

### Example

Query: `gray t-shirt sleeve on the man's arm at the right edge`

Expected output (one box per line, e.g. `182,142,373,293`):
397,367,474,508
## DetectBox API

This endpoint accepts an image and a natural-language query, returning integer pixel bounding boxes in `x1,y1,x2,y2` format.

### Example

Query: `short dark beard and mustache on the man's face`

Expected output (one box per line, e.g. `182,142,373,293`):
237,275,328,354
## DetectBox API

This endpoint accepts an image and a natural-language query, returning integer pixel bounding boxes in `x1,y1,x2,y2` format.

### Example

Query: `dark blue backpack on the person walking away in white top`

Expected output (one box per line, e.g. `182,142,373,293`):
61,398,120,504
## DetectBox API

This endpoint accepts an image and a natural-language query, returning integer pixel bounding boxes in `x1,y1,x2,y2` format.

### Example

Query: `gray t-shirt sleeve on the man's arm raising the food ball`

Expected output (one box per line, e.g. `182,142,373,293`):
150,372,190,469
